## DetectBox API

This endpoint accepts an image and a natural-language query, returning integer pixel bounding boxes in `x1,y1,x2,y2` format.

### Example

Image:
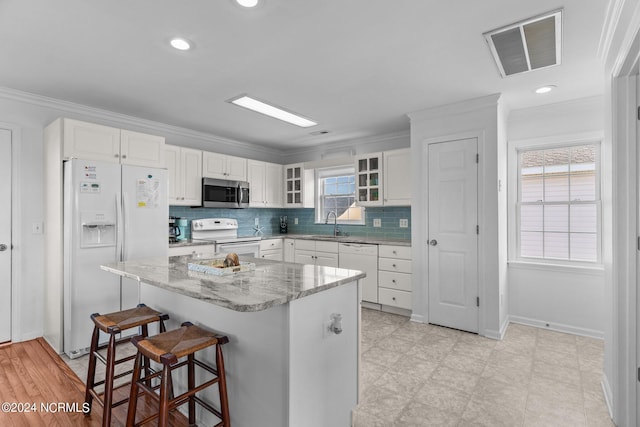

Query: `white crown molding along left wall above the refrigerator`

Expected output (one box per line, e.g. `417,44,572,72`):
0,86,285,156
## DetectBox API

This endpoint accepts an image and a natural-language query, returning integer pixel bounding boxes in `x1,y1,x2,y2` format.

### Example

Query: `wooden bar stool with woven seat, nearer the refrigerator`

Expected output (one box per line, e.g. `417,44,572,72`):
84,304,169,426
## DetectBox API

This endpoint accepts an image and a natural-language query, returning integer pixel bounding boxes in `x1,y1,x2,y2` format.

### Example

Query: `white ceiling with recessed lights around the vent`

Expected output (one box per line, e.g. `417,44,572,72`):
0,0,607,150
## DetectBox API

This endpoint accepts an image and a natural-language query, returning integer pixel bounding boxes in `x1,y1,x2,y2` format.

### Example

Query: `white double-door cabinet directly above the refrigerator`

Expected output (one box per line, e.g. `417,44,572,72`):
63,119,164,168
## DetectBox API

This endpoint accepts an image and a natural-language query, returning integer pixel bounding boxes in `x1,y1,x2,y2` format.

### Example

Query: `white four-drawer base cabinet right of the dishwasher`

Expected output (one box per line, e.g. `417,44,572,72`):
378,245,411,310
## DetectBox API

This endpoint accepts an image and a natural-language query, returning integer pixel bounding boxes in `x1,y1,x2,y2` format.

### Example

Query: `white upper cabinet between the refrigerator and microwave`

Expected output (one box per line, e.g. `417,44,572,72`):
165,145,202,206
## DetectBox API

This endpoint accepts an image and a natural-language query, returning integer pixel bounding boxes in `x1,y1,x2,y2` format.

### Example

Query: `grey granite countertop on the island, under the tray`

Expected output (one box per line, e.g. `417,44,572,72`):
100,255,365,312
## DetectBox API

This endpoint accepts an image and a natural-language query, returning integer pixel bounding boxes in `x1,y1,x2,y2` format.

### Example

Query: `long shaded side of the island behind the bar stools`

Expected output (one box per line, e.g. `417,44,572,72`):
140,283,290,427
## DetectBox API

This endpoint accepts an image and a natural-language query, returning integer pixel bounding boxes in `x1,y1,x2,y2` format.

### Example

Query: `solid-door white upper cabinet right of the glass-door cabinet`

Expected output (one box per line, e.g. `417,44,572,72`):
382,148,411,206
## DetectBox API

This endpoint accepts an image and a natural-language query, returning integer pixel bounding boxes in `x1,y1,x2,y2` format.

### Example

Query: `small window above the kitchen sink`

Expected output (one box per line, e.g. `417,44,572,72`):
316,167,364,224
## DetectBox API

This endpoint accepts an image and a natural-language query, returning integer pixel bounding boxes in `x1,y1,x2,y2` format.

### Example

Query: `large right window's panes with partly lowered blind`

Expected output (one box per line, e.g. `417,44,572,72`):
517,144,601,263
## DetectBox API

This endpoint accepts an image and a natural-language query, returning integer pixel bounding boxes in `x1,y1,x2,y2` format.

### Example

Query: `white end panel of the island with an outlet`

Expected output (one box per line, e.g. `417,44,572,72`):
288,281,360,427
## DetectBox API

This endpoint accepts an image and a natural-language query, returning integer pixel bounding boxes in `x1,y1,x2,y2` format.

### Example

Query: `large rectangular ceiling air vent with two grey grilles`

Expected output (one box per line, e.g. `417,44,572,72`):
484,9,562,77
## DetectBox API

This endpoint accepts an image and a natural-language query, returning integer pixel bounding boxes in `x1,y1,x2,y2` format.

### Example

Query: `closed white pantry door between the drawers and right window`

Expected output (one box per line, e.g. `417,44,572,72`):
428,138,478,332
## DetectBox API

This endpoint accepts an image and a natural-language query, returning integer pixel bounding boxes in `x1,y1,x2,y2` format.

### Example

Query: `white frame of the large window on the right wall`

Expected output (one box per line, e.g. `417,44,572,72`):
507,132,604,268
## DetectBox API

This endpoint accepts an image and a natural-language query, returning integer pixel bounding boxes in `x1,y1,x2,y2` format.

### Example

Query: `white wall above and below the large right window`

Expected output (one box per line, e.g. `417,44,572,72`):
508,97,610,338
